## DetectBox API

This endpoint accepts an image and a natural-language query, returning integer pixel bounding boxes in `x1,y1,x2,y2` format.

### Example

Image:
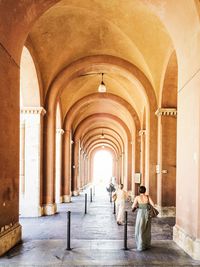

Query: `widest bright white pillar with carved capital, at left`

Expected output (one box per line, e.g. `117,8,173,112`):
20,107,46,217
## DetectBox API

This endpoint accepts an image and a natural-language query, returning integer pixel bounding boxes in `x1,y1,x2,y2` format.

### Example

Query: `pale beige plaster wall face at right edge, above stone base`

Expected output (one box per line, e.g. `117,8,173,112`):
176,74,200,238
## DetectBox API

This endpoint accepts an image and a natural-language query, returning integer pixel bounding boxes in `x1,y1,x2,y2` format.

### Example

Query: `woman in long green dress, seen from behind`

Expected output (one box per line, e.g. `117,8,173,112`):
132,186,154,251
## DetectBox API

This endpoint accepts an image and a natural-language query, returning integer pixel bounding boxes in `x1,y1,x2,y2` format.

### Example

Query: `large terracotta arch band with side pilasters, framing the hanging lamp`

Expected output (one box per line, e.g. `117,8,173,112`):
44,55,157,209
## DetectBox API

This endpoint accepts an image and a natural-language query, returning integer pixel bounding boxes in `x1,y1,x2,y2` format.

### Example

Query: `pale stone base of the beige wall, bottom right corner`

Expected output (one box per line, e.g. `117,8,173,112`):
173,225,200,260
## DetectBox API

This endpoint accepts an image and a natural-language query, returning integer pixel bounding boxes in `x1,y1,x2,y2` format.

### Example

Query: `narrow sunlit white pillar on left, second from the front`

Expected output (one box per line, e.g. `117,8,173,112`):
55,129,64,203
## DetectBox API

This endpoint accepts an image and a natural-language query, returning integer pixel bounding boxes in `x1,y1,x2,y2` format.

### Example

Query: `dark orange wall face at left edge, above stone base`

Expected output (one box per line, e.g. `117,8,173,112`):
0,47,19,228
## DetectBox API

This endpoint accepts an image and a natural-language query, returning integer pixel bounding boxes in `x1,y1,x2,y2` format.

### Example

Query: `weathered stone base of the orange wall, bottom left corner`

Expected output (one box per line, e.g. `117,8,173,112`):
0,223,22,256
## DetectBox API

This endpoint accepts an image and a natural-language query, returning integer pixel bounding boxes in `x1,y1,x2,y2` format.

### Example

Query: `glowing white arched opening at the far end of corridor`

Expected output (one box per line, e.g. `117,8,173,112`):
93,149,113,190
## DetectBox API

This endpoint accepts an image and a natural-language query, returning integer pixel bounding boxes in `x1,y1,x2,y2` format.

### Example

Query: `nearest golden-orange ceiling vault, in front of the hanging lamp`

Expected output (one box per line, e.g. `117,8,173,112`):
29,0,172,99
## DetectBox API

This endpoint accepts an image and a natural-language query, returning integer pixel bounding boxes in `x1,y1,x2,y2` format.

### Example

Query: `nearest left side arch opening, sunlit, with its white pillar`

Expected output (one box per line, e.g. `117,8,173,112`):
19,47,45,217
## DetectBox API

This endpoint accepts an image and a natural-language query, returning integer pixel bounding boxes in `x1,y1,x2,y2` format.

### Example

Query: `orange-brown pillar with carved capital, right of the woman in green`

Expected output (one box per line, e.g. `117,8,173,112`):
156,108,177,217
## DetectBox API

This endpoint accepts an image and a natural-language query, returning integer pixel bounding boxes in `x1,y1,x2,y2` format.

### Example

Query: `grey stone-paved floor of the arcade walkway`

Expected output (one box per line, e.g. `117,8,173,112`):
0,188,200,267
